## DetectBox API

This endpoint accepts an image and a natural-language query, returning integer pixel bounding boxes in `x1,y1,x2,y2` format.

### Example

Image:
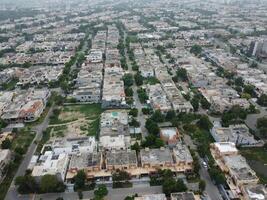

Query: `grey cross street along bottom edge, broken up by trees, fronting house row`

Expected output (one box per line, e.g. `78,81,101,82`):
17,185,162,200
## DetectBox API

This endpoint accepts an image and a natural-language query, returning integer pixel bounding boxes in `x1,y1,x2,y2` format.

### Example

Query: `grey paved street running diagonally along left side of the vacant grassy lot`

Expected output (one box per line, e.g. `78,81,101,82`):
5,106,54,200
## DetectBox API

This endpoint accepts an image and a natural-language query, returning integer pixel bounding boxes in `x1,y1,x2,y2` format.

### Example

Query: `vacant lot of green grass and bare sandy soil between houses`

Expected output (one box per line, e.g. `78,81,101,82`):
49,104,102,137
